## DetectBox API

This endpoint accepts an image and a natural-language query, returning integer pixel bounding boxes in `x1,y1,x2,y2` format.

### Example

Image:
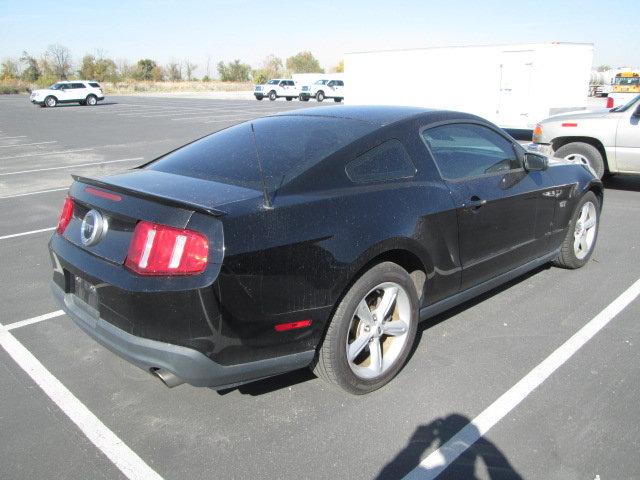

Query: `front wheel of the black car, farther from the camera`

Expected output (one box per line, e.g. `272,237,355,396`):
553,192,600,269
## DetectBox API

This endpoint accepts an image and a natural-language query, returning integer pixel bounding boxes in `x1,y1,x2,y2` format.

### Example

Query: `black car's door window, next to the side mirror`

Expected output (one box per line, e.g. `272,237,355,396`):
422,123,522,180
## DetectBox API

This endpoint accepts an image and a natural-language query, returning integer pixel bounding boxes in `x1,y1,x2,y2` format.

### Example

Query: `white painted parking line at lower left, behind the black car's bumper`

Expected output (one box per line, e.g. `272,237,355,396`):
0,318,162,480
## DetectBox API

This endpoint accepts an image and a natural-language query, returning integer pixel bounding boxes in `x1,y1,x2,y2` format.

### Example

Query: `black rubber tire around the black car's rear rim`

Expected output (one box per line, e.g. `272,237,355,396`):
313,262,419,395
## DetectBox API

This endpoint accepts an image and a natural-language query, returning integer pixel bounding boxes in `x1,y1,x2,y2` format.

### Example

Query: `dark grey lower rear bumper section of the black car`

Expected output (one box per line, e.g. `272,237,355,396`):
51,282,315,388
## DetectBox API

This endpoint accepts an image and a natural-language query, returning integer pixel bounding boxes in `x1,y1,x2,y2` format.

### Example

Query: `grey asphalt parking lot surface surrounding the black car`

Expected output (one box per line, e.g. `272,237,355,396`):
0,96,640,480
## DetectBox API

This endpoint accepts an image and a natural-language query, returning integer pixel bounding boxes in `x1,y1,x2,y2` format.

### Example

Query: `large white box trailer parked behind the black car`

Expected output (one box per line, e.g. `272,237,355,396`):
344,42,593,128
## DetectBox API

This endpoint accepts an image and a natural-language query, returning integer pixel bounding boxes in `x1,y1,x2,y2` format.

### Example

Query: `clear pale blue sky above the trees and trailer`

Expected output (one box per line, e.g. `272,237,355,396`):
0,0,640,75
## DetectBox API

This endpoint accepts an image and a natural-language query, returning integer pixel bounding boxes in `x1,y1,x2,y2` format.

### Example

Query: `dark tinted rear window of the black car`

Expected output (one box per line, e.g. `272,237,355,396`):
144,115,376,192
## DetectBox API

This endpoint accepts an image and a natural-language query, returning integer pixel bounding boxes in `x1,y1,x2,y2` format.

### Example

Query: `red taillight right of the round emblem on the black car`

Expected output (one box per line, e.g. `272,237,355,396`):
125,221,209,275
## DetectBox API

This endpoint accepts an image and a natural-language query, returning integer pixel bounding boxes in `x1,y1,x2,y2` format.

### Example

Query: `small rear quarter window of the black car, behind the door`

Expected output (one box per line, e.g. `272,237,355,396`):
345,140,416,183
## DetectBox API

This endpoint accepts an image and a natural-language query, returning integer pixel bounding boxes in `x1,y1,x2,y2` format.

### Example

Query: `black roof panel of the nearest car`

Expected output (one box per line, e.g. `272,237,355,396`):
274,105,480,127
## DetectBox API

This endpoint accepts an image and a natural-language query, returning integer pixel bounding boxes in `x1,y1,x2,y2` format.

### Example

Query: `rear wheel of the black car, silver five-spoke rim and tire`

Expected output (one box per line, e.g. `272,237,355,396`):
314,262,418,395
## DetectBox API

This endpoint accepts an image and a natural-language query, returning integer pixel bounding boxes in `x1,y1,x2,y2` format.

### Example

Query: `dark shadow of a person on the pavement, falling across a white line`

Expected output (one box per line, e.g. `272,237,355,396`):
376,413,522,480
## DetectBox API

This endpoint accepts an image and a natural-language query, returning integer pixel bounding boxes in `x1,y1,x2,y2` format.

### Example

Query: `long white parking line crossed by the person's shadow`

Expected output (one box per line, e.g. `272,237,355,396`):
404,280,640,480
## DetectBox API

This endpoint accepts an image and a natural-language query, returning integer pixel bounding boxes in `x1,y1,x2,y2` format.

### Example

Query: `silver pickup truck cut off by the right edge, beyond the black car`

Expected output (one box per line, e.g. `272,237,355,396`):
529,95,640,178
